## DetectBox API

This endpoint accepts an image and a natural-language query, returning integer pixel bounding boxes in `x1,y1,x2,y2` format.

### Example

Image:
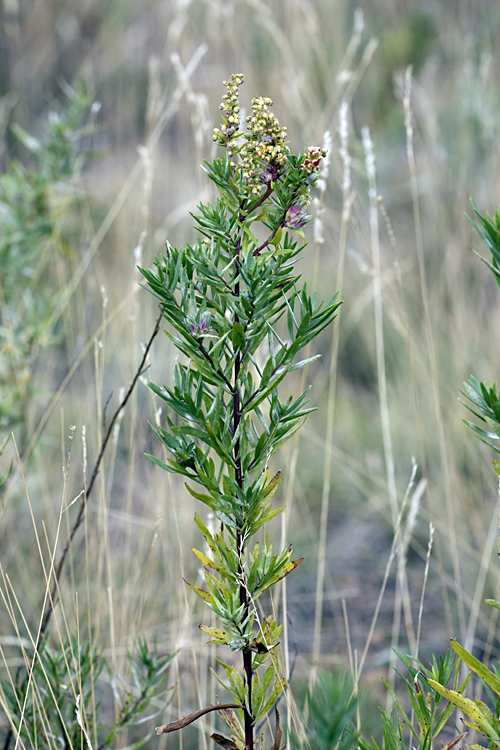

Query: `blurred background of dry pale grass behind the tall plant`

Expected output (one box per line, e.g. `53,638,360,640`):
0,0,500,746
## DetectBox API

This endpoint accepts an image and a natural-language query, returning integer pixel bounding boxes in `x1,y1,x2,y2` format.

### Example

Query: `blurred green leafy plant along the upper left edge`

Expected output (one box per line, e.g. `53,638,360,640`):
0,87,90,440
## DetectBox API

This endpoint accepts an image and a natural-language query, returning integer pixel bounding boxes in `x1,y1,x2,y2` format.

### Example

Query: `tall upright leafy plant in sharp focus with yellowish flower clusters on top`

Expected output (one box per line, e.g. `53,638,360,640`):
142,75,340,750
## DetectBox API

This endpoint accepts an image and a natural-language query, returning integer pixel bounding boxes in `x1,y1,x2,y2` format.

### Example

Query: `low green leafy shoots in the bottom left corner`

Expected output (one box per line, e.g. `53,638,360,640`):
1,639,173,750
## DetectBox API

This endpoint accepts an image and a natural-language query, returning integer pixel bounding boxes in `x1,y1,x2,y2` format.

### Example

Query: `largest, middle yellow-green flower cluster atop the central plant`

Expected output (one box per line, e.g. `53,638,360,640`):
240,96,286,195
